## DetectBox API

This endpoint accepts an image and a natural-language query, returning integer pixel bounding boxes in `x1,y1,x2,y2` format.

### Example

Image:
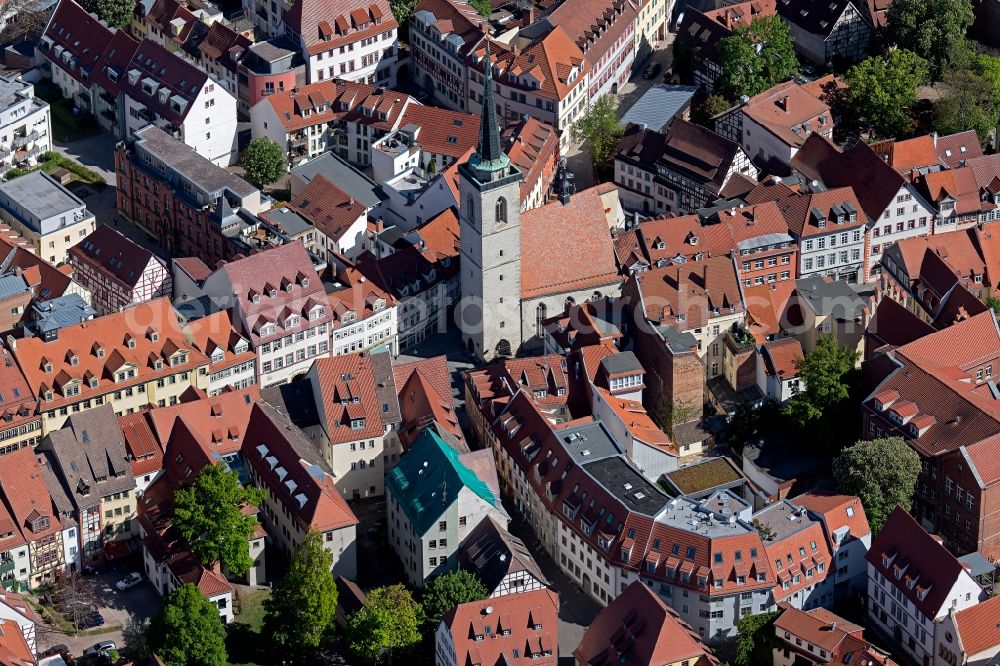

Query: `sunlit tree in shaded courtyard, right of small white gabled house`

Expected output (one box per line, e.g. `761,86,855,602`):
785,334,858,428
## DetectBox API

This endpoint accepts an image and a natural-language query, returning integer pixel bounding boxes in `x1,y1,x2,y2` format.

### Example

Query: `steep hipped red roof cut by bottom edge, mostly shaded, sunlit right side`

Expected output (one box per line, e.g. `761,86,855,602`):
573,580,719,666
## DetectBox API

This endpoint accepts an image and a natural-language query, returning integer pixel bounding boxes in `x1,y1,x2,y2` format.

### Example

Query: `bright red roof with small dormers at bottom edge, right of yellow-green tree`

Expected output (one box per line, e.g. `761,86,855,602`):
441,589,559,666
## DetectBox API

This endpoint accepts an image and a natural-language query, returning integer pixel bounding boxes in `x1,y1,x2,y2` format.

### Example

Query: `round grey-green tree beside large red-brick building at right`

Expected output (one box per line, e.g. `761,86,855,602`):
833,437,920,534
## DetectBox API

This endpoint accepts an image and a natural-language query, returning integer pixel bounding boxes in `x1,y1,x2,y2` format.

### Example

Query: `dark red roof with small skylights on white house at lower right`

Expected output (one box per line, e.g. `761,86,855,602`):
865,507,964,618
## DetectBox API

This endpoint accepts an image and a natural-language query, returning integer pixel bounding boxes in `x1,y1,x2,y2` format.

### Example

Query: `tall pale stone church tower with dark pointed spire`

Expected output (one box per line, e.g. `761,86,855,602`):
457,38,524,360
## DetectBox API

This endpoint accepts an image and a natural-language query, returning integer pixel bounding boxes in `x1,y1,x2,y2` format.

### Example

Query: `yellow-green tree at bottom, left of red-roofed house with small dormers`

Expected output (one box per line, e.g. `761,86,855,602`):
347,584,423,663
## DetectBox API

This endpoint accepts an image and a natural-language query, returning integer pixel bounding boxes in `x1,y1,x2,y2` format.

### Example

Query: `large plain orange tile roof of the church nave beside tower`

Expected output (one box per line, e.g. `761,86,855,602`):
521,185,621,299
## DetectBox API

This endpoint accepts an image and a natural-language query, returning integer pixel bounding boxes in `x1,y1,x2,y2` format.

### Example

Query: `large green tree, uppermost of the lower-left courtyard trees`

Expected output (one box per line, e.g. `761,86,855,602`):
174,463,267,576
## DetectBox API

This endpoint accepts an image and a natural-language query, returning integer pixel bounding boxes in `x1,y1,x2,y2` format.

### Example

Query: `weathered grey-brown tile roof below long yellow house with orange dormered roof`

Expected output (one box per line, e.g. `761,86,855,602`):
40,405,135,509
